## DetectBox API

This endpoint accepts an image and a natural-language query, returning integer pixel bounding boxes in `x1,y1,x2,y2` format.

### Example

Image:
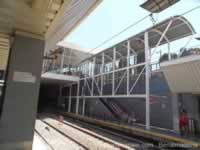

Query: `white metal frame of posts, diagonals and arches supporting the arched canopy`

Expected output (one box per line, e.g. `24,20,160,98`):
65,17,195,130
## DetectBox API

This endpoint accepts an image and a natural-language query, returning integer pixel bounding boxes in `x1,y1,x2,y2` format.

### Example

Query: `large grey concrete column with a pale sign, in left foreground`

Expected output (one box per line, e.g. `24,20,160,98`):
0,35,44,150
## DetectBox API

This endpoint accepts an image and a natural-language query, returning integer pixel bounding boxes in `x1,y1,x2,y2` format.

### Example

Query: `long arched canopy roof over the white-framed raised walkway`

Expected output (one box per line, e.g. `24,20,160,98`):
91,16,195,59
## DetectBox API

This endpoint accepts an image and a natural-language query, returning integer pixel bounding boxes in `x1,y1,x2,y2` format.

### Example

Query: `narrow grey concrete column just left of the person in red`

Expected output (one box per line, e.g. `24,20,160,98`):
172,94,179,132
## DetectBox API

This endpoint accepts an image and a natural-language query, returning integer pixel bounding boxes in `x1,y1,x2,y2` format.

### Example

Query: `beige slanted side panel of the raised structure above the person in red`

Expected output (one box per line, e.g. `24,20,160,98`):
161,55,200,94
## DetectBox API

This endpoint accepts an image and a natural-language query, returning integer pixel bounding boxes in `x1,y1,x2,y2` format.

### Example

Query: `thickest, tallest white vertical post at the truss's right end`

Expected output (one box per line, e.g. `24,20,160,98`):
144,32,150,130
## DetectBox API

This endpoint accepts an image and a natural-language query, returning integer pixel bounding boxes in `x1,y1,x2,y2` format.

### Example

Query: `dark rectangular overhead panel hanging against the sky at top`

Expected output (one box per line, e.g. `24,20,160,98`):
140,0,180,13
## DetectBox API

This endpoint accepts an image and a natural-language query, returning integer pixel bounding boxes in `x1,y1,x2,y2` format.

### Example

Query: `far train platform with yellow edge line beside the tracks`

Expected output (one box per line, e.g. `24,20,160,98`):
63,113,200,148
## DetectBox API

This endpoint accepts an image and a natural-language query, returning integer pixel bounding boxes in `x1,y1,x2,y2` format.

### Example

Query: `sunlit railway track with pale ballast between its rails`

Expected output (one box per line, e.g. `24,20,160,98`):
36,118,133,150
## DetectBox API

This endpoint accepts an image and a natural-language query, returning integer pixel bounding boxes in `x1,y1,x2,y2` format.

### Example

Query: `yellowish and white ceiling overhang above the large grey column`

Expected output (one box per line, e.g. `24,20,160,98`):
0,0,101,50
